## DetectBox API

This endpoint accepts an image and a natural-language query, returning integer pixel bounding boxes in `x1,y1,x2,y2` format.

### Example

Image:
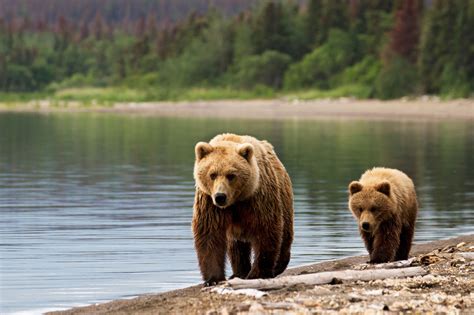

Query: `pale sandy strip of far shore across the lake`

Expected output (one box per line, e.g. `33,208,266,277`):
0,98,474,121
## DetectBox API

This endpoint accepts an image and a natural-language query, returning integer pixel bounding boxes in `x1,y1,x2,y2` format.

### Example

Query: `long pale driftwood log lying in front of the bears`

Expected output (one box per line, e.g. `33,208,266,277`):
224,267,427,290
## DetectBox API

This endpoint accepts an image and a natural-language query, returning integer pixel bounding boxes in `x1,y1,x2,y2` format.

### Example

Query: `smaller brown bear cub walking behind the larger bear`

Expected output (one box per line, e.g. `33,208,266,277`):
349,167,418,263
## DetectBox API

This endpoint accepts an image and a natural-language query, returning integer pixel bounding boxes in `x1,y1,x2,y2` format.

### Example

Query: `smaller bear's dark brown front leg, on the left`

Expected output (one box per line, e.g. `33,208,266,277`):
370,224,400,264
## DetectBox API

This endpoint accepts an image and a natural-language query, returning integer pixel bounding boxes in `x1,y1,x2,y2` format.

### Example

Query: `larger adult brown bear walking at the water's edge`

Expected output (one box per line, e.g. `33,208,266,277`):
192,134,293,286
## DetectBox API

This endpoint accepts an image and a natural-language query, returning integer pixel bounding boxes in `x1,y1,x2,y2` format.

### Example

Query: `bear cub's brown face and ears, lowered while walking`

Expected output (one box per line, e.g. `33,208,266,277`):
349,181,396,234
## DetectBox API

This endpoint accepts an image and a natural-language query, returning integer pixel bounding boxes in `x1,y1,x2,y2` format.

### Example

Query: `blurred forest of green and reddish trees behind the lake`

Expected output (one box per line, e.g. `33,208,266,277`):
0,0,474,100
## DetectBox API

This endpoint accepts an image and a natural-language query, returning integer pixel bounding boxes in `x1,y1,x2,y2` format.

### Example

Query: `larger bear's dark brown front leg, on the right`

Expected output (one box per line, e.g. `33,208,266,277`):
247,235,280,279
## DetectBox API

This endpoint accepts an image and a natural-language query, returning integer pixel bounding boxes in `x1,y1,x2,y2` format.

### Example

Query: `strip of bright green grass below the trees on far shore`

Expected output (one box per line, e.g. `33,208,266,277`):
0,85,378,107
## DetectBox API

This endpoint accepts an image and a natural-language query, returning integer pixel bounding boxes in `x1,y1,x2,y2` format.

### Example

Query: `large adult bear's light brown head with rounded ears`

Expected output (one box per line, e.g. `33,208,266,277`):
194,141,259,209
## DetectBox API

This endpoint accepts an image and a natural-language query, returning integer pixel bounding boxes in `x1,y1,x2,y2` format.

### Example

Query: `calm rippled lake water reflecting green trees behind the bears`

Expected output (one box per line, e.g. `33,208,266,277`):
0,114,474,313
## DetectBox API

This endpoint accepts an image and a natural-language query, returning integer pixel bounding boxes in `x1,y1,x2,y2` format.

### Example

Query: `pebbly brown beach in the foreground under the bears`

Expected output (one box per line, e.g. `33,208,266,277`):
51,234,474,314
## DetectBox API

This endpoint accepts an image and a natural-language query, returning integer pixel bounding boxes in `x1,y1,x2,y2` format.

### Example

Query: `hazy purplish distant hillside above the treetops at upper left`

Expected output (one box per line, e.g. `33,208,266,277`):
0,0,258,25
